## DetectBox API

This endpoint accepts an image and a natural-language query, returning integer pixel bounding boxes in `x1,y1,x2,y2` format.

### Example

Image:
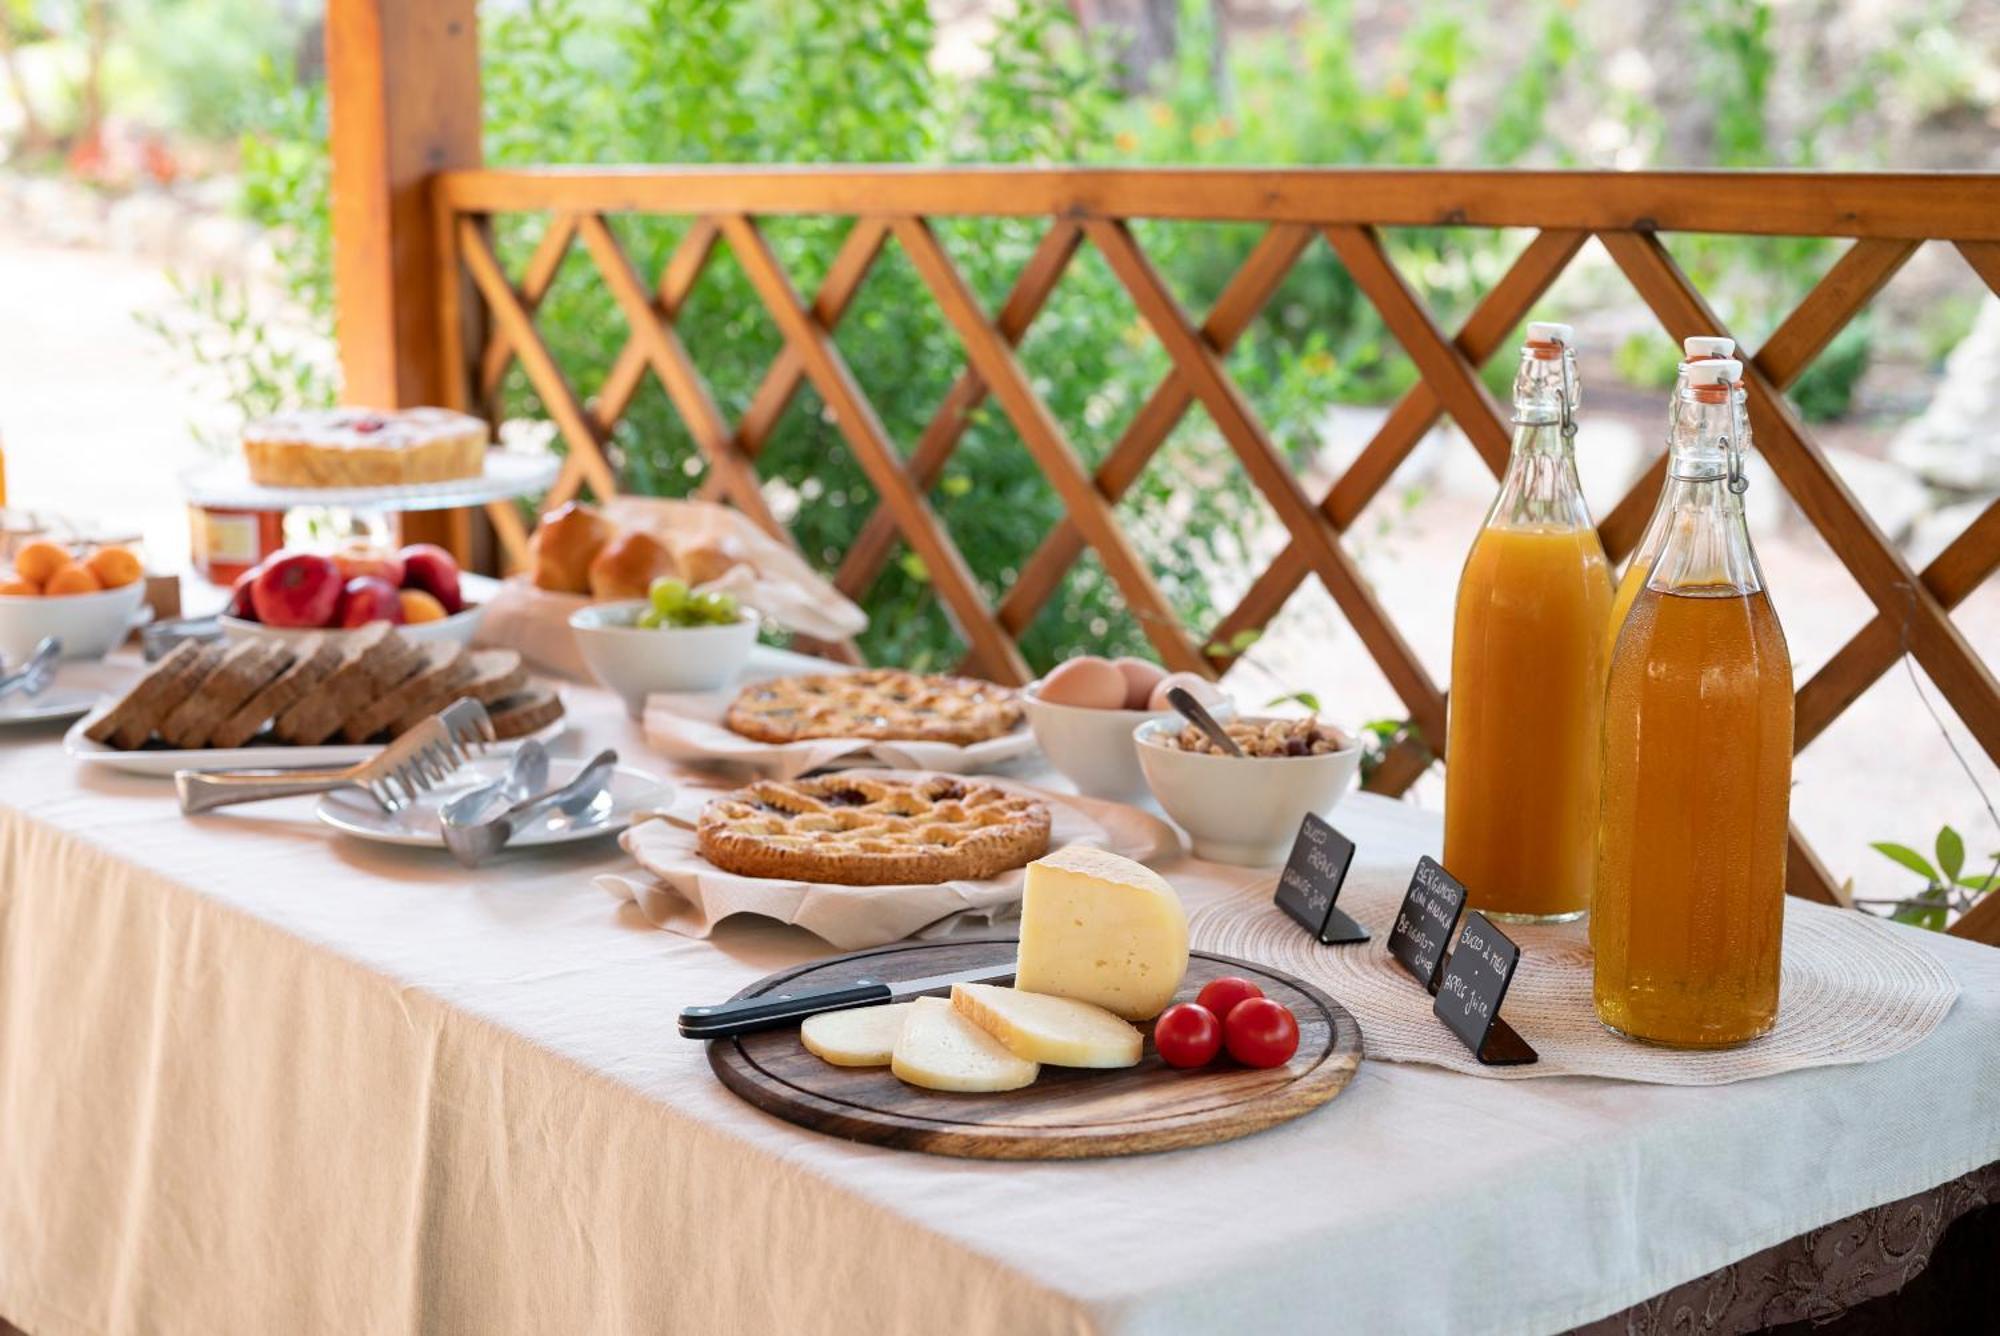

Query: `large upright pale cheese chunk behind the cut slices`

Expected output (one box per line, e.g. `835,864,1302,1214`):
1014,844,1188,1020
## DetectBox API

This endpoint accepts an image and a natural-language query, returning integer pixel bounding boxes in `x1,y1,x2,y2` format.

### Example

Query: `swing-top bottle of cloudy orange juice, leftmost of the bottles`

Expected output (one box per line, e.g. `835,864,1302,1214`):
1444,322,1612,920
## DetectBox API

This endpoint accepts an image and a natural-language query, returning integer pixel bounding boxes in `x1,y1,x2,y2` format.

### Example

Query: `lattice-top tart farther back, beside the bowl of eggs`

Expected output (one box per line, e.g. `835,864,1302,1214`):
722,668,1020,746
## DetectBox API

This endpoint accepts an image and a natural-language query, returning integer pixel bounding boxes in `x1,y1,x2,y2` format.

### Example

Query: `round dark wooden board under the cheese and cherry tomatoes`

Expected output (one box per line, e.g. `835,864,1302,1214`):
708,938,1362,1160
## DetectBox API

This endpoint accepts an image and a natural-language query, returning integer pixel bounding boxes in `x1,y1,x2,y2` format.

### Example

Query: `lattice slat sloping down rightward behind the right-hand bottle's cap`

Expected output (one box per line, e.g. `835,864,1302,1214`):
1604,232,2000,758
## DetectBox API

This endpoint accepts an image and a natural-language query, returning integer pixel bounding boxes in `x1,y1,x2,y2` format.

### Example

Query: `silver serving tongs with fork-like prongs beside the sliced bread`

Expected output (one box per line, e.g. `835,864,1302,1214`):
174,698,494,816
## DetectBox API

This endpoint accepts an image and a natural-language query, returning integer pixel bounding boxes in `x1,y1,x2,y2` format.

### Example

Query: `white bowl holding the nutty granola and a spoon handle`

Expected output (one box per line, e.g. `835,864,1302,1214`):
1134,720,1362,868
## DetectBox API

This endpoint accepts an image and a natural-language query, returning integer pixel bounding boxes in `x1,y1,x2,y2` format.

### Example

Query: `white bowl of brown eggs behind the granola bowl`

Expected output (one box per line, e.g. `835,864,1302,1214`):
1020,654,1228,802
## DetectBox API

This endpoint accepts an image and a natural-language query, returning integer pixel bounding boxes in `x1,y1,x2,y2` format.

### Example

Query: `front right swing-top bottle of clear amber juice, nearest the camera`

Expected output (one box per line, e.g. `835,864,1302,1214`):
1590,360,1792,1048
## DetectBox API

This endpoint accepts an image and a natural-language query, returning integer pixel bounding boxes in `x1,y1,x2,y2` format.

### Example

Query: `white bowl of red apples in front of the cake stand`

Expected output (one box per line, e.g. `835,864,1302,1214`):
222,542,482,644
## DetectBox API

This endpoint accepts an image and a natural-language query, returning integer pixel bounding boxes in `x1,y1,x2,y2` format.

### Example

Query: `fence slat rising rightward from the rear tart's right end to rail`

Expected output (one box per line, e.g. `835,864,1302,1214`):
1000,224,1312,652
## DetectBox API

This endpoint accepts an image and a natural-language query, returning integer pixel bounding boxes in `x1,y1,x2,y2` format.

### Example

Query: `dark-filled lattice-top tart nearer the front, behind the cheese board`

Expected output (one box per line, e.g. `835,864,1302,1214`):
696,774,1048,886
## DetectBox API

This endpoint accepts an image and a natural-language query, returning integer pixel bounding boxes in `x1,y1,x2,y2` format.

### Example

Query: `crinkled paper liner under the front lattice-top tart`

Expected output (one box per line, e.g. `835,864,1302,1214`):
596,784,1180,950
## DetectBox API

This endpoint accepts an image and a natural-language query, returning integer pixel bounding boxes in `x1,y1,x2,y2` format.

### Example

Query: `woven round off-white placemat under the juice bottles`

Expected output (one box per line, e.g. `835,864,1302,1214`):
1190,868,1958,1086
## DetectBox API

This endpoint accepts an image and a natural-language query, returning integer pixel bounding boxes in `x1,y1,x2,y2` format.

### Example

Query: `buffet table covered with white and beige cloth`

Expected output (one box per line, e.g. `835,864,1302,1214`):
0,660,2000,1336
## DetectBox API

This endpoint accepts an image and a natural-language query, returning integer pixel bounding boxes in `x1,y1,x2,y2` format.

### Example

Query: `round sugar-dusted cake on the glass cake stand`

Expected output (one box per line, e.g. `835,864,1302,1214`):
244,408,488,488
